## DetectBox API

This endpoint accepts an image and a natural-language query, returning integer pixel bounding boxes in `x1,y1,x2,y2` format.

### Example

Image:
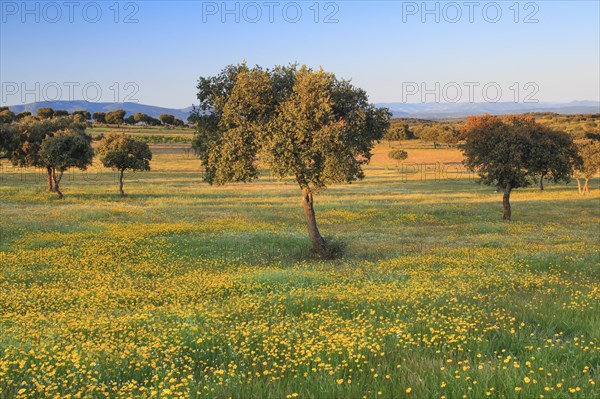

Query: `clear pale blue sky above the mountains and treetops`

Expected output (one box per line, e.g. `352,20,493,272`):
0,0,600,108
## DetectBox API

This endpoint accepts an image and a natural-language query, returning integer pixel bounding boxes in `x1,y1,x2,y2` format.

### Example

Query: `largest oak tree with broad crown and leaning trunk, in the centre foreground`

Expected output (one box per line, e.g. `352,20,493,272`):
194,64,391,256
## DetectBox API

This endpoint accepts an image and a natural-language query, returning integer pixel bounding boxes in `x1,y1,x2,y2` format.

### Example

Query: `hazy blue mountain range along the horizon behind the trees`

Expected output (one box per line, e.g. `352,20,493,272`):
3,101,600,121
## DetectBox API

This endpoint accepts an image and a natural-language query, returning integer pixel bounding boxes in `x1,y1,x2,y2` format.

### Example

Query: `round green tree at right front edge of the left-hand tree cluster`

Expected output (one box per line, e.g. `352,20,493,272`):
40,129,94,199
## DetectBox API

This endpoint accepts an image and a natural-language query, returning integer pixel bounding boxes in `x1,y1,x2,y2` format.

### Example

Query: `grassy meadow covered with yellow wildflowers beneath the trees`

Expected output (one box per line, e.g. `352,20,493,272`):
0,129,600,399
